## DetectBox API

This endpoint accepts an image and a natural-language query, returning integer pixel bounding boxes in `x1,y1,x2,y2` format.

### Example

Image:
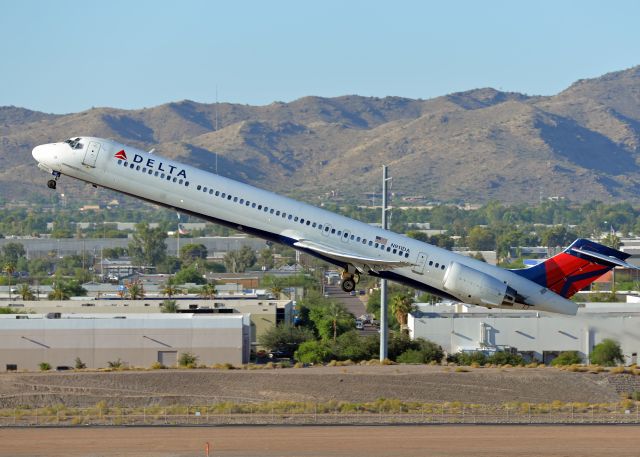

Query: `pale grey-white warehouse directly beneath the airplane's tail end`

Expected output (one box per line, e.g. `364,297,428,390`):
408,303,640,364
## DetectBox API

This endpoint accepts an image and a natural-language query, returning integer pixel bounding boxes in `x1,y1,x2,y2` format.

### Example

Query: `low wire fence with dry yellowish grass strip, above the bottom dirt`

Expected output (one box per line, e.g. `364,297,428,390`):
0,400,640,427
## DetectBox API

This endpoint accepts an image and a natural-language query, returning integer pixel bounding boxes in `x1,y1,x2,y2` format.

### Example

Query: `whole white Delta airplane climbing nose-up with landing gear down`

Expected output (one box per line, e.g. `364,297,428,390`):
32,136,636,315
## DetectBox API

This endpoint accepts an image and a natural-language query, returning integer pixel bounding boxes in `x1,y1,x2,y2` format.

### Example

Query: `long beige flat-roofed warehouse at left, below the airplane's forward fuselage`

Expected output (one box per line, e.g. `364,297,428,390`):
0,313,250,371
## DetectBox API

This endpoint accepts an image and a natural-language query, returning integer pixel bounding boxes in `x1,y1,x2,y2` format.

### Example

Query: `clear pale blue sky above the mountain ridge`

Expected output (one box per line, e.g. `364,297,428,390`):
0,0,640,113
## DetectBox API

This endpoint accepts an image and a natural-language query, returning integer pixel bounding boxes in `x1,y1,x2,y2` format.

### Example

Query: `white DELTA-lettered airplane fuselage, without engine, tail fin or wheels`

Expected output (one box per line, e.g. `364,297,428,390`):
33,137,576,314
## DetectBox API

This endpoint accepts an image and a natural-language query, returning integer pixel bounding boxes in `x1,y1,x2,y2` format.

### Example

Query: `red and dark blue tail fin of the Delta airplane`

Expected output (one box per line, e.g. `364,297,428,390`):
513,238,638,298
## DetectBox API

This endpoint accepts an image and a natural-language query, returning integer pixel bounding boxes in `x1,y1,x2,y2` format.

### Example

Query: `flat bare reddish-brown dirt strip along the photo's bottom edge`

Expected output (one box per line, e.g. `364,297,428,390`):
0,426,640,457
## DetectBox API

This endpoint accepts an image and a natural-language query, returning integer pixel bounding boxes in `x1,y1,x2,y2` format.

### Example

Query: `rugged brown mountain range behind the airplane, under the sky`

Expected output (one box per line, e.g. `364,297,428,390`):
0,66,640,203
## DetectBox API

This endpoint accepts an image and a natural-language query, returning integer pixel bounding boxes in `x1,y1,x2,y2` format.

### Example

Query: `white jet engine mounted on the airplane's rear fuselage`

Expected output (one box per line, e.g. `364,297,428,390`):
443,262,517,307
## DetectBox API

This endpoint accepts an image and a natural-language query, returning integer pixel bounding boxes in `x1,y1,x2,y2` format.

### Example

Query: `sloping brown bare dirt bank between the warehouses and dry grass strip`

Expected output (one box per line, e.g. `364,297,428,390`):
0,365,624,406
